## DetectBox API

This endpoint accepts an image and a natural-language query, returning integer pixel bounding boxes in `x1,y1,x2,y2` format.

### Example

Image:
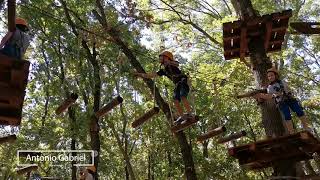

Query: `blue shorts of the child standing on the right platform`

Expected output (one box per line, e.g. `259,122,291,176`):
279,99,304,121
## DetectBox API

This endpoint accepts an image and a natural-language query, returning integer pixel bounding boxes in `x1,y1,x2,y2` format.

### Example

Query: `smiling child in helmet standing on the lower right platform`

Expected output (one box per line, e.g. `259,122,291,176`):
258,67,311,134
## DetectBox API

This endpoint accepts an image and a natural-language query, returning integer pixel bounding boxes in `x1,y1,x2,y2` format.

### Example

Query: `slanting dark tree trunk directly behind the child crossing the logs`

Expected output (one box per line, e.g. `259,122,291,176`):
93,0,197,180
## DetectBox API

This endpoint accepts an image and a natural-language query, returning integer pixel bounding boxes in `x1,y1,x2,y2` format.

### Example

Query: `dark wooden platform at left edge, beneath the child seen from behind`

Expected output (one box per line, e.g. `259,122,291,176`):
0,53,30,126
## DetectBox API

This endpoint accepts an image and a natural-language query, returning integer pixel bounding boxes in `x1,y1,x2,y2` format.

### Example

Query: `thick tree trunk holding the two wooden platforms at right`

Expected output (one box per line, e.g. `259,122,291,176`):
235,0,296,177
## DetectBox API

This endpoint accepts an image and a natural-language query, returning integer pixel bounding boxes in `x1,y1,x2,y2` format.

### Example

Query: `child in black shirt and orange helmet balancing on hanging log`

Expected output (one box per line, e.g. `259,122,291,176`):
135,51,193,124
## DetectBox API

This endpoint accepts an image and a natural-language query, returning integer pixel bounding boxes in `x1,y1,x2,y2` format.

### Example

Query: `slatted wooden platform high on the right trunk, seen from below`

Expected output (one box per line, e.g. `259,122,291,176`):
223,10,292,60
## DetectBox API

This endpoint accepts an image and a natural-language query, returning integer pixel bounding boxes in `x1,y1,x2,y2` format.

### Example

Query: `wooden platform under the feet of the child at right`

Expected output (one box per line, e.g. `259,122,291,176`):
228,131,320,169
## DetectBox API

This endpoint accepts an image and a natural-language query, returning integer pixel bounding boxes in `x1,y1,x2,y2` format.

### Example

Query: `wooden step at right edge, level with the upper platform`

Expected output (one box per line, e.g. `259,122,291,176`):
290,22,320,34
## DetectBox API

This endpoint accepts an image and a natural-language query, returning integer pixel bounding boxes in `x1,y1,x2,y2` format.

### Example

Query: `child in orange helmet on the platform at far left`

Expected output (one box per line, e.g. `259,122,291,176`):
0,18,30,59
